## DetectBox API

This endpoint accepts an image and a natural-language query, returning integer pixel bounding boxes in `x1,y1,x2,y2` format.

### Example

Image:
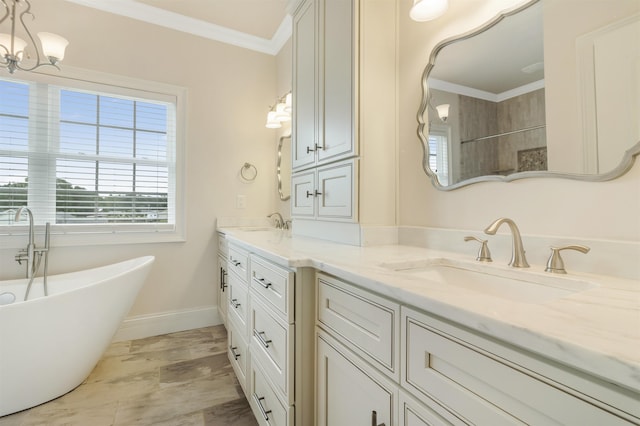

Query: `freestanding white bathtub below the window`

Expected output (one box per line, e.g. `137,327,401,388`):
0,256,154,416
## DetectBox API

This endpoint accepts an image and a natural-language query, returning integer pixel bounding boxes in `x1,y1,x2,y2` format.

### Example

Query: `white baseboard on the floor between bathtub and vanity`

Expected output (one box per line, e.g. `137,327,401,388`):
113,306,222,342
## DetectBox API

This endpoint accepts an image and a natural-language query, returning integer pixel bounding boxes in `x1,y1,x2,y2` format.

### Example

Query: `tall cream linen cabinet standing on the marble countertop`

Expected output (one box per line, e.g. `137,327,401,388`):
291,0,398,245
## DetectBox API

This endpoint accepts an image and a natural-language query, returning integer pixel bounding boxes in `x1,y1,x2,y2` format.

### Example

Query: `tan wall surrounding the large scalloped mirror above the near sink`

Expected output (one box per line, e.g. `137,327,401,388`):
399,0,640,242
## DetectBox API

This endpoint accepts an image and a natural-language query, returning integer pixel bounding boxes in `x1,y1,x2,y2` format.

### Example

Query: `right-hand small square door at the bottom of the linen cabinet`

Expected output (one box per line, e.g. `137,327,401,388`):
316,161,356,220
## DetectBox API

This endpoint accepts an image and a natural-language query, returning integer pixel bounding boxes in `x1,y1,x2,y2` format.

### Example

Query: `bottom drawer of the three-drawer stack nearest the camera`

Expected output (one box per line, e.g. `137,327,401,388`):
247,362,294,426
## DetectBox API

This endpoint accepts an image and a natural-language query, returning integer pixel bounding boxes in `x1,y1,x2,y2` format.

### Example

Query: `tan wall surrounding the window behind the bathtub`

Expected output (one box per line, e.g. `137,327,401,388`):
0,0,277,315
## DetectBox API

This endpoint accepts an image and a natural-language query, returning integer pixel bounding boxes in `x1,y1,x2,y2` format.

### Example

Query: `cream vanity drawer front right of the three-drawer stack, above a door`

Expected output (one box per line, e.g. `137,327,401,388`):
316,273,400,380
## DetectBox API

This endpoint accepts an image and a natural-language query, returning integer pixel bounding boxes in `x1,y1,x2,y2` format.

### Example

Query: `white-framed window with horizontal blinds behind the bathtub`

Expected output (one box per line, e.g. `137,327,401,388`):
0,69,181,243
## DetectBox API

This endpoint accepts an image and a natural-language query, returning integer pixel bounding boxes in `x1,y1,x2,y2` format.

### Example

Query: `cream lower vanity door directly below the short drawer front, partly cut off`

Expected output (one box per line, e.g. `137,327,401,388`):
316,333,397,426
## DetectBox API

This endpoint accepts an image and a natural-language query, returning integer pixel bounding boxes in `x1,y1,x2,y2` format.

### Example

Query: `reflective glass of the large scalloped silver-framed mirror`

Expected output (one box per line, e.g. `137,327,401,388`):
418,0,640,189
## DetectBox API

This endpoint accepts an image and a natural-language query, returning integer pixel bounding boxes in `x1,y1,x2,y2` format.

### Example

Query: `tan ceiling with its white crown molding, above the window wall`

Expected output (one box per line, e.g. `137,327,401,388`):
61,0,291,55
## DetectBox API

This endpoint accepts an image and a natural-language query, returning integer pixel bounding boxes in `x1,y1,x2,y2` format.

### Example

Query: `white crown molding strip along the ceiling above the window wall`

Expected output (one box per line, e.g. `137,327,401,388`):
61,0,292,55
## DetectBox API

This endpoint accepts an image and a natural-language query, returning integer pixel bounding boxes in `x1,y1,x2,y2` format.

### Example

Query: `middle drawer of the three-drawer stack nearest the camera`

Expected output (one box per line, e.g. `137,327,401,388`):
249,299,294,404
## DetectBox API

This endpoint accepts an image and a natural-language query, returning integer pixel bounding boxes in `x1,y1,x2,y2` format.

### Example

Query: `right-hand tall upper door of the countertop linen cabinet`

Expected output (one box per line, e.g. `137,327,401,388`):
318,0,358,163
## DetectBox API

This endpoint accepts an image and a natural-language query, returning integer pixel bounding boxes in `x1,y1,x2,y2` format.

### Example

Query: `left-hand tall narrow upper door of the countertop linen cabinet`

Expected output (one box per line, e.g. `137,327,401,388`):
291,0,319,170
